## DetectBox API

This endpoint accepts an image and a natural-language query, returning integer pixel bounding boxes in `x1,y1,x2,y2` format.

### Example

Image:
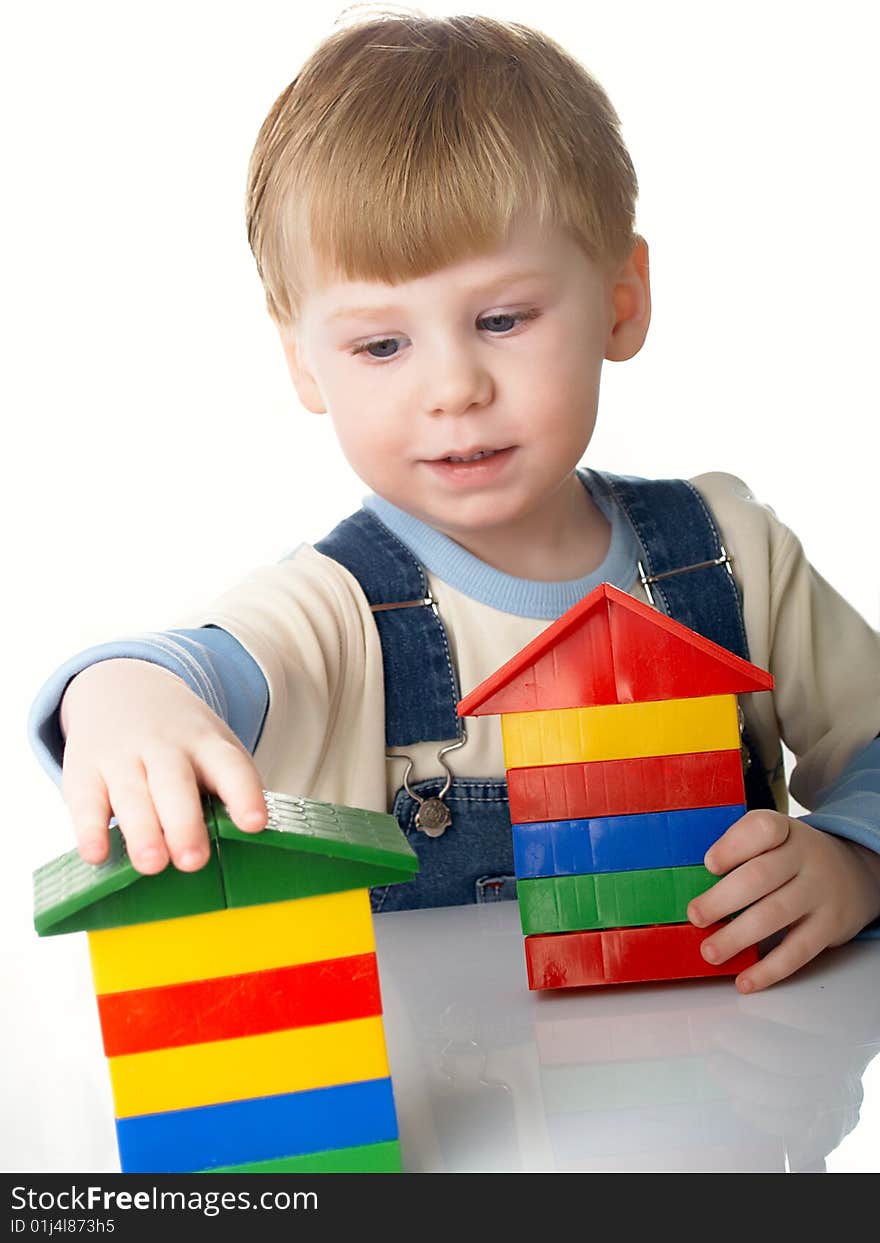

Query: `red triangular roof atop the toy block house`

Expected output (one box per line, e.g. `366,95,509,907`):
457,583,773,716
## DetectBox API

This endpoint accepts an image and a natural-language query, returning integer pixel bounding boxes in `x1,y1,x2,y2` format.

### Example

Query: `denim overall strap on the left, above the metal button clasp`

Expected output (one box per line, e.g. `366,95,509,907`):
314,510,462,747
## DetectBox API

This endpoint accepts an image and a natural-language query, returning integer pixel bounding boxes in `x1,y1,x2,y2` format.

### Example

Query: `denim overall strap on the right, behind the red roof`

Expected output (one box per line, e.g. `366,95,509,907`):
594,471,776,808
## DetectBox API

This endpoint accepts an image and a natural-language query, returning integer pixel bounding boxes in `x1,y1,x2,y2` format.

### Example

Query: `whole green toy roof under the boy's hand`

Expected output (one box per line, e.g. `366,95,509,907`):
34,791,419,936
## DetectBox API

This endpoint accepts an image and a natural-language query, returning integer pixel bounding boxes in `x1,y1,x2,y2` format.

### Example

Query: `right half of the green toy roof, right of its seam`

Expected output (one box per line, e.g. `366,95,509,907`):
209,793,419,906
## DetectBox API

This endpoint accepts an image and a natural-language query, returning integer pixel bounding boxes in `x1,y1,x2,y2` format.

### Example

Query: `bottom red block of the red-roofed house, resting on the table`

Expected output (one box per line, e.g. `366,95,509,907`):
525,924,758,989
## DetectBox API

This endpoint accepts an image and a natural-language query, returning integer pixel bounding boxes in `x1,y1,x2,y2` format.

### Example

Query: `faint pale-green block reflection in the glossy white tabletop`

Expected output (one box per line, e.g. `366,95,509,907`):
541,1054,728,1114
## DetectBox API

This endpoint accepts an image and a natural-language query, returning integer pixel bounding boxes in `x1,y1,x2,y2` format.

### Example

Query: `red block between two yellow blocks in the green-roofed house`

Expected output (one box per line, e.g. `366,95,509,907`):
98,953,382,1058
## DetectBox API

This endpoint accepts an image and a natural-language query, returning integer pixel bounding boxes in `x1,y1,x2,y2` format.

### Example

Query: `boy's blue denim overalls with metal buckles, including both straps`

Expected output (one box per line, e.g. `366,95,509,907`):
314,471,774,911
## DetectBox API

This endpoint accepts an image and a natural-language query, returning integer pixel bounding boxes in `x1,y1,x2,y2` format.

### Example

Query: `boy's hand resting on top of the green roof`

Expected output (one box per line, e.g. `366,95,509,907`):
60,659,268,874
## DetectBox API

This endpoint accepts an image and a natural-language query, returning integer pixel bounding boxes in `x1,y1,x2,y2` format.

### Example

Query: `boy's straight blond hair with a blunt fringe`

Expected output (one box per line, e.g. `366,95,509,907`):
247,11,638,326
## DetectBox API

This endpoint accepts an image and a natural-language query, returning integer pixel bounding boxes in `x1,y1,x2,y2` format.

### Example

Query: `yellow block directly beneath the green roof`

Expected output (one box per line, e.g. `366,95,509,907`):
88,889,375,993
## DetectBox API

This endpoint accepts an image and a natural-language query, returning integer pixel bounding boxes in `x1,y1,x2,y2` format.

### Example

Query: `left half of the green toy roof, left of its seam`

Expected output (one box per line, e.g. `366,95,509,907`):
34,827,226,936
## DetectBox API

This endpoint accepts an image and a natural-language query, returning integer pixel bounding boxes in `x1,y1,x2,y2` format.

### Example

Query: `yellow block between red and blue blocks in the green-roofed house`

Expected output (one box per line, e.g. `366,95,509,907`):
108,1016,389,1117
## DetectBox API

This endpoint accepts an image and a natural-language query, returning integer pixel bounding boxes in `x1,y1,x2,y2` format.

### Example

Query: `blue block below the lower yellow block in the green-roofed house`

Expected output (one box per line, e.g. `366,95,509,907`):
116,1078,398,1173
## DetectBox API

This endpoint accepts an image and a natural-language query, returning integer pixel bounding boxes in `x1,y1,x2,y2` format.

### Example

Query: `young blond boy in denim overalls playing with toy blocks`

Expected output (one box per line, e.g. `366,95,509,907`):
31,16,880,992
